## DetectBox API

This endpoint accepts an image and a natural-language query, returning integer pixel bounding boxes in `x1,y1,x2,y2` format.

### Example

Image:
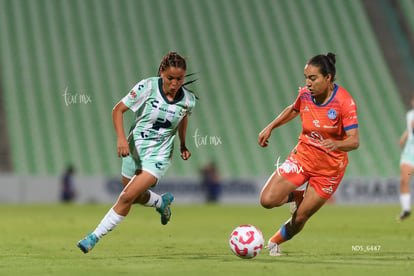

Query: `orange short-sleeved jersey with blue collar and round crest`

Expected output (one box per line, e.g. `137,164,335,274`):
293,84,358,176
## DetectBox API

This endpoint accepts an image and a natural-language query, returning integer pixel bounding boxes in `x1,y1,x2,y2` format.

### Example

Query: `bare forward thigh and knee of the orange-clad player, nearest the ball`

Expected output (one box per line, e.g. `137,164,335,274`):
260,171,297,207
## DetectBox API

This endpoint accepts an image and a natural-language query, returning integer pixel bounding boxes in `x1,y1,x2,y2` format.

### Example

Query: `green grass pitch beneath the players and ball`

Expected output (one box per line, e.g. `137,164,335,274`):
0,204,414,276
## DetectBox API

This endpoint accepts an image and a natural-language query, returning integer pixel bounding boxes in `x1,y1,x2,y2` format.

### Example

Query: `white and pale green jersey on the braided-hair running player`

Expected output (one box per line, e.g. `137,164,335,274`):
122,77,196,160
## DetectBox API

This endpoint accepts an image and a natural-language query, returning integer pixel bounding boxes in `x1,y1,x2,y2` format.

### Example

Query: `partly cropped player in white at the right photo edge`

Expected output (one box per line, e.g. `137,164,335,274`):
398,96,414,221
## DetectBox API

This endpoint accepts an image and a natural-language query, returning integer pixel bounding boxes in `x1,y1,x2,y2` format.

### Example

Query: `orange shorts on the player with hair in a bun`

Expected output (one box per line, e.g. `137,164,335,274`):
276,155,345,199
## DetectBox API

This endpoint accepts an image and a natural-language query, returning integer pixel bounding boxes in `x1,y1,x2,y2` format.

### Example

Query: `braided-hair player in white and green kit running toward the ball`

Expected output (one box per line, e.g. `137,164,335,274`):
77,52,196,253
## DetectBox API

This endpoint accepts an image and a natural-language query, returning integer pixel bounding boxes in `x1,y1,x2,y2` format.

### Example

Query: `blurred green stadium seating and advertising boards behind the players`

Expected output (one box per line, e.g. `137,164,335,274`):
0,0,414,204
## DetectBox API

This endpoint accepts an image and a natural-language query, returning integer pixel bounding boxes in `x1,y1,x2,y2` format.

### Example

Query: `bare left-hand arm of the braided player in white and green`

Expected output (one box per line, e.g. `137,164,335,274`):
112,100,129,157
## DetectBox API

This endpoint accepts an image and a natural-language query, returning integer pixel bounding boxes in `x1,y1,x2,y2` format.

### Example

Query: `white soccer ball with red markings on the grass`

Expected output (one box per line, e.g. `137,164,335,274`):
229,225,264,259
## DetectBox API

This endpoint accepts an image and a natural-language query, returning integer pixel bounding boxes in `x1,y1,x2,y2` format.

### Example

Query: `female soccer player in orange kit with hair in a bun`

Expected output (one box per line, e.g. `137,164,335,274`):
259,53,359,256
